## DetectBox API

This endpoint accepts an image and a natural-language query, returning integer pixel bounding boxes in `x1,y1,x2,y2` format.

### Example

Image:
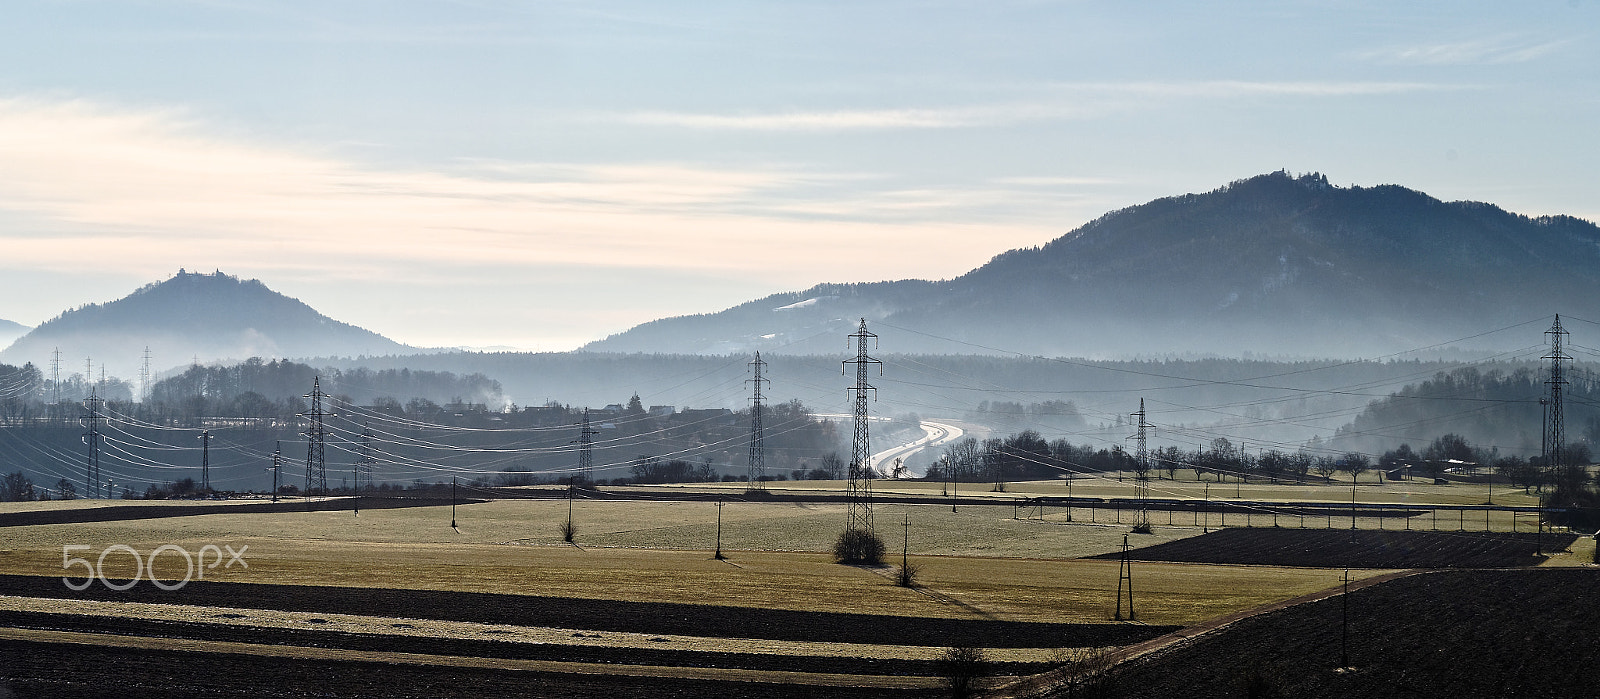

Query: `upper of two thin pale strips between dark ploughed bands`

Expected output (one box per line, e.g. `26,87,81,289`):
0,595,1053,662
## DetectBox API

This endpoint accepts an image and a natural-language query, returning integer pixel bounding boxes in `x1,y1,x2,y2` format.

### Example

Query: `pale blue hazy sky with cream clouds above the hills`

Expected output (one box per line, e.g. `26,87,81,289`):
0,0,1600,350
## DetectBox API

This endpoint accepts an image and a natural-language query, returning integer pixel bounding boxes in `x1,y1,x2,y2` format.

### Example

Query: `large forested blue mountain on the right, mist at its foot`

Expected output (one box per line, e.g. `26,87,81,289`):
584,173,1600,357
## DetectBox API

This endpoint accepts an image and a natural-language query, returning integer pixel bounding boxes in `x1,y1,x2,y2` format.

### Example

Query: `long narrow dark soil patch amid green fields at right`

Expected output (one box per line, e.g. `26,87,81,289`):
1094,529,1578,568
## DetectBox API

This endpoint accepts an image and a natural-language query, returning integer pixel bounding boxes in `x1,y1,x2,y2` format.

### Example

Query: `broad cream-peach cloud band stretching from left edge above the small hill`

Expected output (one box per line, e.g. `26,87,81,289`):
0,99,1054,283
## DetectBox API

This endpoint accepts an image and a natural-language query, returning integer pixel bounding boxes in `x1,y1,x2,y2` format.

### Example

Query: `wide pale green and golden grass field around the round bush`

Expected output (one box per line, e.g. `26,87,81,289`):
0,501,1376,624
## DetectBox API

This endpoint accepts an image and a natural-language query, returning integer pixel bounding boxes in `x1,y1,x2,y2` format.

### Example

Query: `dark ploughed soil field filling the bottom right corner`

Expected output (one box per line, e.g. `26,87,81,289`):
1037,568,1600,699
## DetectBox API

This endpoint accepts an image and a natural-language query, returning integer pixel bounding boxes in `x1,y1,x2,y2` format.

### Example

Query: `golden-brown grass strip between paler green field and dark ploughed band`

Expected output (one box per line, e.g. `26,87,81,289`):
0,542,1363,630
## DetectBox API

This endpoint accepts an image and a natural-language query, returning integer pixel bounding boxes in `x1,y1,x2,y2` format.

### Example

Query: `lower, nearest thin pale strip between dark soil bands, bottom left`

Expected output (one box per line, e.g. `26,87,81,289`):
0,627,941,688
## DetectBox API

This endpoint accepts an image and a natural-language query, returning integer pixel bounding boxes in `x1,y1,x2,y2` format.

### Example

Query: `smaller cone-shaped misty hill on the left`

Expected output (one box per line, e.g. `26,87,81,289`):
0,270,416,377
